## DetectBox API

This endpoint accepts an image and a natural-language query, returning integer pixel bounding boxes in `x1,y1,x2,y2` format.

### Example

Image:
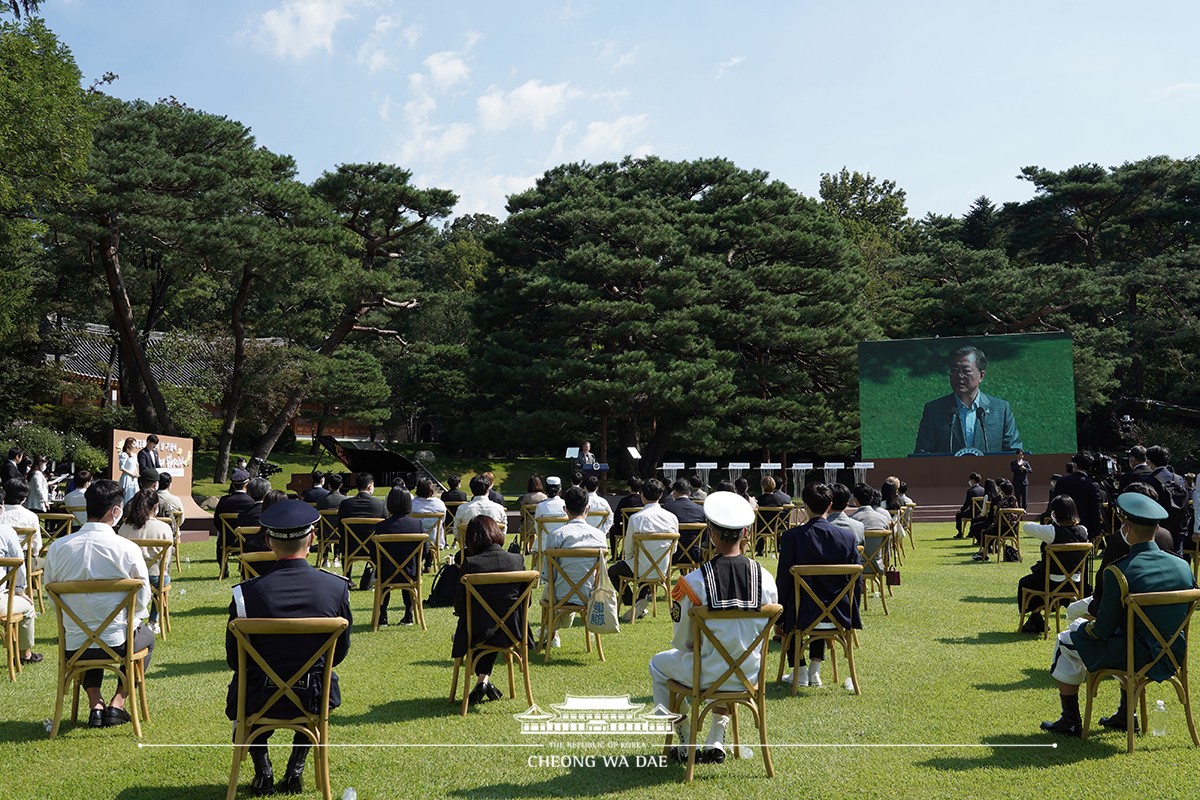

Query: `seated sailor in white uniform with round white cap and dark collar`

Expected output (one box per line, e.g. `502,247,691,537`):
650,492,779,763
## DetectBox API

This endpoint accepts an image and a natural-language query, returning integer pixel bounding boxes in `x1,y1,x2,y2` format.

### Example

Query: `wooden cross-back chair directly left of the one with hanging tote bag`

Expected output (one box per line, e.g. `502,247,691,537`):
450,570,538,716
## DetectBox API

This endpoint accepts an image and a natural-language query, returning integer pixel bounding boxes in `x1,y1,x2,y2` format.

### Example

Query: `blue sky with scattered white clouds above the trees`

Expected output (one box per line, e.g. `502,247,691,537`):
35,0,1200,217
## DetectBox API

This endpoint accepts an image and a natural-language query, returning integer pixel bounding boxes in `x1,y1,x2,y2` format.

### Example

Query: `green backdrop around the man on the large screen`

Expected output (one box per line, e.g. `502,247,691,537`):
858,333,1075,459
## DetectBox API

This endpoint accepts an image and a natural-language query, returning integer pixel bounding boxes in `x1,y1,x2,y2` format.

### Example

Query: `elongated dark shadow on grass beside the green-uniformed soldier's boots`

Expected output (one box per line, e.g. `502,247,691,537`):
918,722,1124,774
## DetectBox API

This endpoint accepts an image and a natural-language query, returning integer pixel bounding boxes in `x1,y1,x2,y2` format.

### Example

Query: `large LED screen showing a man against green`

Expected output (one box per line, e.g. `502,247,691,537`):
858,333,1075,459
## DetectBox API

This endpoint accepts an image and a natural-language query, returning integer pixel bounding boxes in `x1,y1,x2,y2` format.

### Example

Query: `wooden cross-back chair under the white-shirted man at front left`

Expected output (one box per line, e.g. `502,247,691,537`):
46,578,150,739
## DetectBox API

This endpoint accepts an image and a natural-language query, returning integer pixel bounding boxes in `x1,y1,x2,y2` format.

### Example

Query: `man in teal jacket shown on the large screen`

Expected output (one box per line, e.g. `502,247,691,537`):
913,344,1022,455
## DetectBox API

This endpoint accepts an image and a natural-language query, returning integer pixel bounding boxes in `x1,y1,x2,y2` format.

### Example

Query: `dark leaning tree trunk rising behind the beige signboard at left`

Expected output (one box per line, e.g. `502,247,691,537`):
100,215,175,435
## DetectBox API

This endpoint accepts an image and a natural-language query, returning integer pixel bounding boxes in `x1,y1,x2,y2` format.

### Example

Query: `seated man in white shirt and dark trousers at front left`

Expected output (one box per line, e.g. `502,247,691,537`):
46,480,155,728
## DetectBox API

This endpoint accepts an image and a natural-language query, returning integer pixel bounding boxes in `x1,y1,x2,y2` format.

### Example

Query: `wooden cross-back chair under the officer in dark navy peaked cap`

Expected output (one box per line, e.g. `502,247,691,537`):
226,616,349,800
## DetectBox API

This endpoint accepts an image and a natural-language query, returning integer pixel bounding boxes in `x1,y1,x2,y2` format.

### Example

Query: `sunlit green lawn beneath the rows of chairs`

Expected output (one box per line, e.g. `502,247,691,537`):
7,524,1200,800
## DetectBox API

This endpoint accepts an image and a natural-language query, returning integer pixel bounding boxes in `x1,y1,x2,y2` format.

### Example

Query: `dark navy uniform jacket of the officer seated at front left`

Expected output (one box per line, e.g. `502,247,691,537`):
226,558,353,744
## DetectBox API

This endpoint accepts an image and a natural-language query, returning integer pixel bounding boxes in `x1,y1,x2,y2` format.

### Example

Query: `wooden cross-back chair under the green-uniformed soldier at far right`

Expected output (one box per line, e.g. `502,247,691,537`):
1082,587,1200,753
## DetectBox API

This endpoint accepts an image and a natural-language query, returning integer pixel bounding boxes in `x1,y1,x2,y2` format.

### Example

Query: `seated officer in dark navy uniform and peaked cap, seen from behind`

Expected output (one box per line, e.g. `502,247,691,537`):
226,500,353,795
